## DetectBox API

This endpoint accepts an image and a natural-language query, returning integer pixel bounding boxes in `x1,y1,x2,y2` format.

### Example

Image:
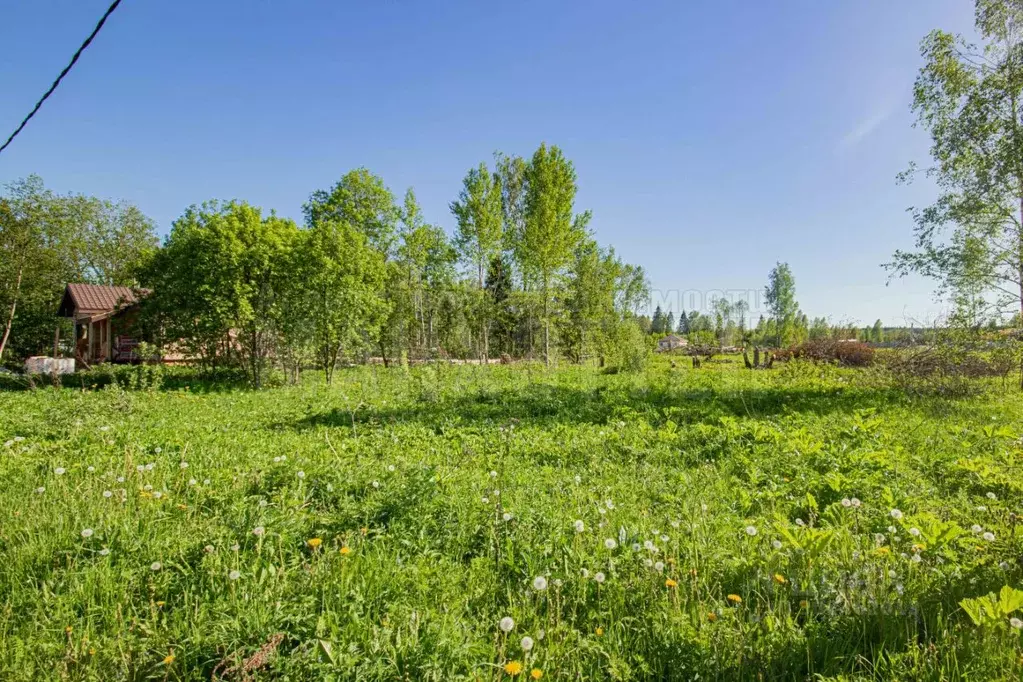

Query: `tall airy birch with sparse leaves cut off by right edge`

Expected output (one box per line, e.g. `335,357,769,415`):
886,0,1023,321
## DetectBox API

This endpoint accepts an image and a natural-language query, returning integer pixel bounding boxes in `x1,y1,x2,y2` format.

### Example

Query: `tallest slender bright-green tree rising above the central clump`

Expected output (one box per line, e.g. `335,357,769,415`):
519,144,590,366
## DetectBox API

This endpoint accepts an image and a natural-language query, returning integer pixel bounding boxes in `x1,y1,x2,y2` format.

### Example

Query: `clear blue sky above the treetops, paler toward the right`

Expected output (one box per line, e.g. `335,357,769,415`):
0,0,973,324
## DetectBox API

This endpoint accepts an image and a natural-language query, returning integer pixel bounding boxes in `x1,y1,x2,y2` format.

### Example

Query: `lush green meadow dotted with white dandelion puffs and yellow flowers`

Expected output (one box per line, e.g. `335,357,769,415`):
0,358,1023,680
